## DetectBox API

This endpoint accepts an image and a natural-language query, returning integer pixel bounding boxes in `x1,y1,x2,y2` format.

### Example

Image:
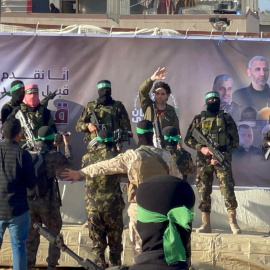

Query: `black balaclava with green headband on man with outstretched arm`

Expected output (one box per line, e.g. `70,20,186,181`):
136,120,154,146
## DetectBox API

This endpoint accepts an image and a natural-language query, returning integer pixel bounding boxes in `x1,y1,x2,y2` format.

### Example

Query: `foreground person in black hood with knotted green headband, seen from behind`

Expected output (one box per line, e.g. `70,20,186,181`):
129,175,195,270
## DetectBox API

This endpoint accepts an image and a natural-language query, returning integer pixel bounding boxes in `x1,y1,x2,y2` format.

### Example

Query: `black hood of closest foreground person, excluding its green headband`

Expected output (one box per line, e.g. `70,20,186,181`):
130,175,195,270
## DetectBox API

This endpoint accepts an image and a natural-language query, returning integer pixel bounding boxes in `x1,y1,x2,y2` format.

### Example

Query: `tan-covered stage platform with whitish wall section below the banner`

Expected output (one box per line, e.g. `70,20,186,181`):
0,182,270,270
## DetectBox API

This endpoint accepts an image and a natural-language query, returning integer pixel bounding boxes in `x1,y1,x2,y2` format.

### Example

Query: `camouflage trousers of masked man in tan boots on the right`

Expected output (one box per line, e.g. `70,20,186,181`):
196,160,237,212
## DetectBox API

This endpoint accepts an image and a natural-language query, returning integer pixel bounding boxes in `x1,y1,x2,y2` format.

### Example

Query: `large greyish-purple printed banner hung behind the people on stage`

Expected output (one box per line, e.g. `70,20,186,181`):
0,35,270,187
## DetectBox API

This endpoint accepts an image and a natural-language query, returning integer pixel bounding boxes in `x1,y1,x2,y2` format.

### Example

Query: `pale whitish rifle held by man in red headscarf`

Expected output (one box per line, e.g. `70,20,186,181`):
15,110,35,149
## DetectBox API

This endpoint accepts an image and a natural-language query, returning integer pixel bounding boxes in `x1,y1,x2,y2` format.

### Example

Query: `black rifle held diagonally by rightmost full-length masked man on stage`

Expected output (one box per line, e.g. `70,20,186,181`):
192,127,230,170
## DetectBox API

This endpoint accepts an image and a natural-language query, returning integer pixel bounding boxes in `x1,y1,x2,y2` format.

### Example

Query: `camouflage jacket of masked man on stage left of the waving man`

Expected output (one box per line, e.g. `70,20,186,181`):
75,100,131,141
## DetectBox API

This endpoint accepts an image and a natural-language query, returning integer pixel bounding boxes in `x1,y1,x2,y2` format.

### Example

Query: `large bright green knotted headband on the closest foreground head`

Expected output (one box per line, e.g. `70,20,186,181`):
137,205,195,264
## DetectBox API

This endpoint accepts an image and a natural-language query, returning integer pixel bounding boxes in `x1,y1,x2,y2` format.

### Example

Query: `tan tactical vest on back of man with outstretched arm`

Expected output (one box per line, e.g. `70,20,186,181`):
138,146,169,185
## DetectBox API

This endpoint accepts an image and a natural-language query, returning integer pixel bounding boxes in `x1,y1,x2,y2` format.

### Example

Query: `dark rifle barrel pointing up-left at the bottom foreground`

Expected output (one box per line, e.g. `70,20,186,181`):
33,222,100,270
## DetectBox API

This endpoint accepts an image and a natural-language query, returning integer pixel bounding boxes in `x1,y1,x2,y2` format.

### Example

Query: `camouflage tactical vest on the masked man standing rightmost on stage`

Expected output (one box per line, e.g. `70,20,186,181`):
201,110,230,148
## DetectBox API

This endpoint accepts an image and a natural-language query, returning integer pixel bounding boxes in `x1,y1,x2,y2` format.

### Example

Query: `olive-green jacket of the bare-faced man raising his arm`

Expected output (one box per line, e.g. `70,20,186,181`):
139,78,181,137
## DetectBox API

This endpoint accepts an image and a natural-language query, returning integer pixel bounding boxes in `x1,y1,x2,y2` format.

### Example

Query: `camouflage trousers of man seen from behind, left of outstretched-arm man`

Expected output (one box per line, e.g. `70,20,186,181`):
87,207,124,269
